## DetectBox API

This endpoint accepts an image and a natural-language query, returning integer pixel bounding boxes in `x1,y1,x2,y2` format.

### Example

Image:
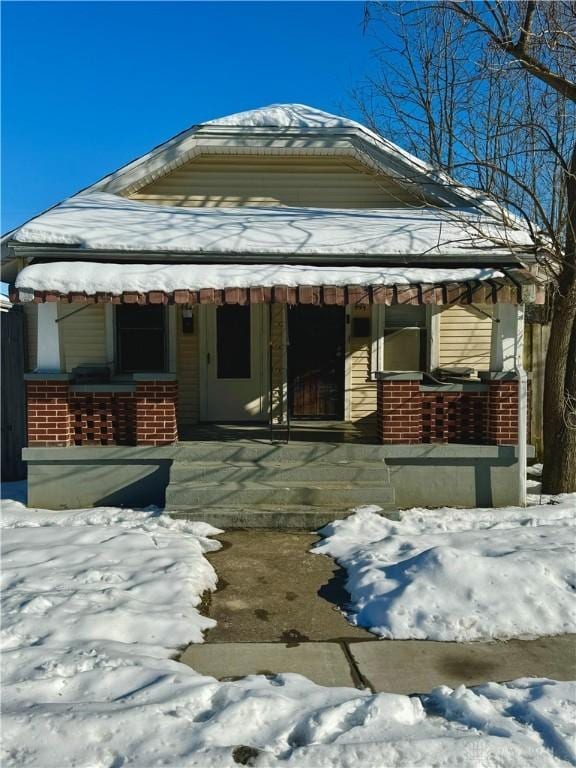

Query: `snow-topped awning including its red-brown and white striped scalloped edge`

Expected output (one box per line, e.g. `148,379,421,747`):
16,261,538,304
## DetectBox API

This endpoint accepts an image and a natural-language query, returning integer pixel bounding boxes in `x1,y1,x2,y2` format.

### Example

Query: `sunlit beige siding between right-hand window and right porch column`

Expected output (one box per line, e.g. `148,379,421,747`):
438,305,492,370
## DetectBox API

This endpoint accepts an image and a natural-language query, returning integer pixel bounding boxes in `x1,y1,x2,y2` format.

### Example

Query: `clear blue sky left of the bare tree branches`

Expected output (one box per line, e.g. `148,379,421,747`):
2,1,374,232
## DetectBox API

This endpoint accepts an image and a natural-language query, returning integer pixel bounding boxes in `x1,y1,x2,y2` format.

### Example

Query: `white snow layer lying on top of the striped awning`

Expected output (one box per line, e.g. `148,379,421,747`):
16,261,504,295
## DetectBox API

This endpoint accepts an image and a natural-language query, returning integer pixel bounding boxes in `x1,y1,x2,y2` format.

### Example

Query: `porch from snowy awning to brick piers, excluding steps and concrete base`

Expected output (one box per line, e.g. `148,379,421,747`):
15,262,544,447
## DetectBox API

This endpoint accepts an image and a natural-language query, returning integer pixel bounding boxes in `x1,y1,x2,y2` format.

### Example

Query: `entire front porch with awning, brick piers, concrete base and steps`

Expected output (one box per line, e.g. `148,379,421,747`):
16,263,544,516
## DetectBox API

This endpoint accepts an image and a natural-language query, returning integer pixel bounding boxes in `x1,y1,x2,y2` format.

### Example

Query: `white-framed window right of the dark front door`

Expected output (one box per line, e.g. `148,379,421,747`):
372,304,427,372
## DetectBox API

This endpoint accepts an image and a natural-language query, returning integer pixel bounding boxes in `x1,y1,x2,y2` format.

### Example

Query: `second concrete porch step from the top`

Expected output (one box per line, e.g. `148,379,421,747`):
170,461,390,485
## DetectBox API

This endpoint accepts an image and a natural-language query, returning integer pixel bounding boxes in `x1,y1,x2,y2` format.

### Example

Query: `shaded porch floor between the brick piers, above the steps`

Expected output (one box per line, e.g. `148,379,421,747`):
179,420,377,445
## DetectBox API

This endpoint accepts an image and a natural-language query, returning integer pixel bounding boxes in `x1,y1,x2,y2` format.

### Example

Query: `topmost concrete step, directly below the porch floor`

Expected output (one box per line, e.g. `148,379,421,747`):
176,440,386,464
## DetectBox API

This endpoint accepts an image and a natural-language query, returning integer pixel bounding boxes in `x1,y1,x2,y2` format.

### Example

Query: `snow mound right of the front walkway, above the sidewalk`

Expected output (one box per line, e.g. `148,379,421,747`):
315,494,576,641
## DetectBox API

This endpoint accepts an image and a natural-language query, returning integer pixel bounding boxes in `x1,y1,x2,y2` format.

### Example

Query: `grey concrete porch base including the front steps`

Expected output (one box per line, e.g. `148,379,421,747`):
23,440,533,512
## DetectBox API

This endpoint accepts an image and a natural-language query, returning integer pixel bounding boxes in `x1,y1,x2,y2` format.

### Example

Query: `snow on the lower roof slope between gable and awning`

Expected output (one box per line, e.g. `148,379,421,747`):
12,192,534,259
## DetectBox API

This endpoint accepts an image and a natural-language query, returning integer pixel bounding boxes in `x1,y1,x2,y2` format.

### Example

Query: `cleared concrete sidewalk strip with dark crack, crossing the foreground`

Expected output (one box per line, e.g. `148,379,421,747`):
180,635,576,693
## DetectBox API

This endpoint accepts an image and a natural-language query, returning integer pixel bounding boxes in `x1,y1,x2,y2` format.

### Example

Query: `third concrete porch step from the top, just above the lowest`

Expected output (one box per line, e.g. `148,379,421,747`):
166,481,394,509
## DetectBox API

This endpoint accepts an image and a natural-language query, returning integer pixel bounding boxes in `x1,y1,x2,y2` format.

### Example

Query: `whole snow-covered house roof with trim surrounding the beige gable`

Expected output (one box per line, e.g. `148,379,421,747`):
2,104,534,268
